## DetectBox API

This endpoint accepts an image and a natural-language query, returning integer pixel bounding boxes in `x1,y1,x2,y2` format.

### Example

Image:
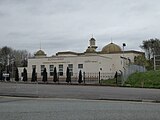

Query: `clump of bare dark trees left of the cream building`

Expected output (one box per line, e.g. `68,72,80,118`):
0,46,30,80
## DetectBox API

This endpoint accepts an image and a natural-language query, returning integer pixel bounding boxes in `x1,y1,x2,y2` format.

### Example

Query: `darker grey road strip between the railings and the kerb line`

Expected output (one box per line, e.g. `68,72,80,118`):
0,82,160,102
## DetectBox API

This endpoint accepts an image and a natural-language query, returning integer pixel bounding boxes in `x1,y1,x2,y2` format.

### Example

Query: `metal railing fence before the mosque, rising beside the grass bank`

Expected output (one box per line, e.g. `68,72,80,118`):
1,65,146,85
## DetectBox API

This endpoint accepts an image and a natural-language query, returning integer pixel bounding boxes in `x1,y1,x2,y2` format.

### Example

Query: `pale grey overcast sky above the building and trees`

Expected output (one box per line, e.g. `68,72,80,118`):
0,0,160,55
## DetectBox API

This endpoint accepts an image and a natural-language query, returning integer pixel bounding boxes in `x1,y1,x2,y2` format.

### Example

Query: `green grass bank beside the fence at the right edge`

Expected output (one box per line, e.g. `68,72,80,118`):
125,71,160,88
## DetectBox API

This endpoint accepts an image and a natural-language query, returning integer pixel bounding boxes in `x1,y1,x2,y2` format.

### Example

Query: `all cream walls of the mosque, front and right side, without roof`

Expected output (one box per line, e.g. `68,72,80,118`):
19,53,142,80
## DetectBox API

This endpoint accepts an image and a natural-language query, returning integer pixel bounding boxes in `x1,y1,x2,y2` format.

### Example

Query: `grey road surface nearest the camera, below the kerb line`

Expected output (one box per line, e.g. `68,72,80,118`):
0,97,160,120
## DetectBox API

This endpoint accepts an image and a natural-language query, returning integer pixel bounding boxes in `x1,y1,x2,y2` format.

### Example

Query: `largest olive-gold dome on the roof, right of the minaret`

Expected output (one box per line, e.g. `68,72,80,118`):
101,43,122,53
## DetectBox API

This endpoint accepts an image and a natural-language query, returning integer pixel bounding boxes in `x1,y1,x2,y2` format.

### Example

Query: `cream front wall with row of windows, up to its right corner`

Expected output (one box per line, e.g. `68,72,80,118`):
27,55,113,79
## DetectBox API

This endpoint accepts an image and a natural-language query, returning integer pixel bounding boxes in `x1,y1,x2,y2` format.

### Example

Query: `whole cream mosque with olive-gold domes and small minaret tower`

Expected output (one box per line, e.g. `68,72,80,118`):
19,37,144,79
